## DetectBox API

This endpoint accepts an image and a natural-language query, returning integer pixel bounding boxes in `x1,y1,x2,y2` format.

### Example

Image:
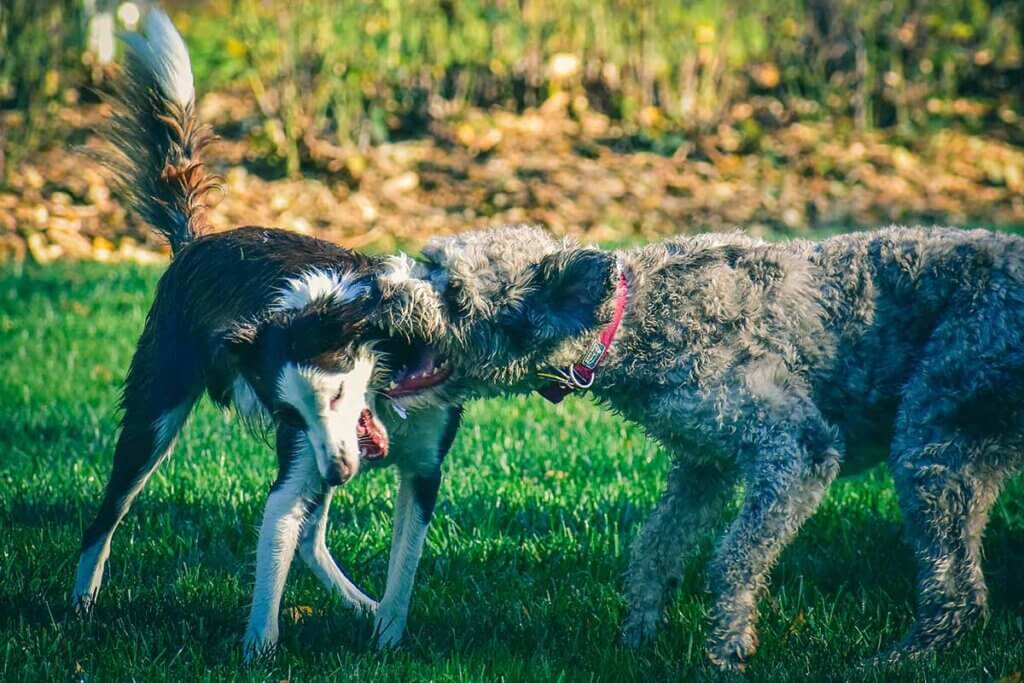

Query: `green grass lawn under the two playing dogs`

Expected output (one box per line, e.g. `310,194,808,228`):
0,265,1024,682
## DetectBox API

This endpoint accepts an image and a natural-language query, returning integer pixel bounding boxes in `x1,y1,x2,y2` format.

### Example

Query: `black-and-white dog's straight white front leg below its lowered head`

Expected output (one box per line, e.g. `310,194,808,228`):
244,427,324,661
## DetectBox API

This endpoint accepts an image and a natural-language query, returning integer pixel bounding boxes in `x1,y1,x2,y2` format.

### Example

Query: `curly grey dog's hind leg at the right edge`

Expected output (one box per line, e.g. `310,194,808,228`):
879,294,1024,663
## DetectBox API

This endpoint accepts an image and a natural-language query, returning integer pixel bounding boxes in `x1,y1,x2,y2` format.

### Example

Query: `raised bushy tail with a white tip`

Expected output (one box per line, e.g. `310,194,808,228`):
102,9,217,254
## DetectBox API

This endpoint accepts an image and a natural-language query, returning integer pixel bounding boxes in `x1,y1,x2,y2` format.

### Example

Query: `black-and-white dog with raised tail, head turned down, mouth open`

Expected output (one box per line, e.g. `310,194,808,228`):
72,11,458,657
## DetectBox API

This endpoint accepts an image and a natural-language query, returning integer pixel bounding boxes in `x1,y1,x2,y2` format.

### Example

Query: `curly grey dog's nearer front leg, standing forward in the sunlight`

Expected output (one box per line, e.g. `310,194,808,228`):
709,430,840,670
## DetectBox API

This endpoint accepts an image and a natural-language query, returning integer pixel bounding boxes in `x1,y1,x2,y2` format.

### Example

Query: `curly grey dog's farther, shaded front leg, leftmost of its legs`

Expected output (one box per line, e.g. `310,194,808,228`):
622,462,734,647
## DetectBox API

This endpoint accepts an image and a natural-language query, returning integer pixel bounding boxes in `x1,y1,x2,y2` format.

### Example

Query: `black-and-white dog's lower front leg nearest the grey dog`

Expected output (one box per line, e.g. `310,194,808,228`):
375,469,441,648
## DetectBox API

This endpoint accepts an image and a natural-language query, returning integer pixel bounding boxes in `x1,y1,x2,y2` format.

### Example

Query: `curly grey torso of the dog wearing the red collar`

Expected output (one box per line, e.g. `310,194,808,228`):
597,227,1024,455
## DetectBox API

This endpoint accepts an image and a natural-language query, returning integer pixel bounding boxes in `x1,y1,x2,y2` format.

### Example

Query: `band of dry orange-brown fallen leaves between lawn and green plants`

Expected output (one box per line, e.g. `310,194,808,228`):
0,90,1024,263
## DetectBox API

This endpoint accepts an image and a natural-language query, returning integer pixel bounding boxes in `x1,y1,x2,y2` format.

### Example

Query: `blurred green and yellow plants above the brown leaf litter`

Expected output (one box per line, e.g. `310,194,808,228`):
8,0,1024,173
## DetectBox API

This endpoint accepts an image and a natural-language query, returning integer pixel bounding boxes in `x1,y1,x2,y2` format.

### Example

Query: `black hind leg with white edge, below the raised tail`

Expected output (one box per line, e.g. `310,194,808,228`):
72,337,202,611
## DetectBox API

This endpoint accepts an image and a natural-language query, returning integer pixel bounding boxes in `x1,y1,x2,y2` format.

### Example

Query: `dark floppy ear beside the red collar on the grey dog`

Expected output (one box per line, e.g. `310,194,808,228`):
522,249,614,341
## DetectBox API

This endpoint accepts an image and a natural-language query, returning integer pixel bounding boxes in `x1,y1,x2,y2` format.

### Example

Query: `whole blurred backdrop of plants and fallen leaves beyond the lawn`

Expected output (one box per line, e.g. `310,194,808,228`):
0,0,1024,260
